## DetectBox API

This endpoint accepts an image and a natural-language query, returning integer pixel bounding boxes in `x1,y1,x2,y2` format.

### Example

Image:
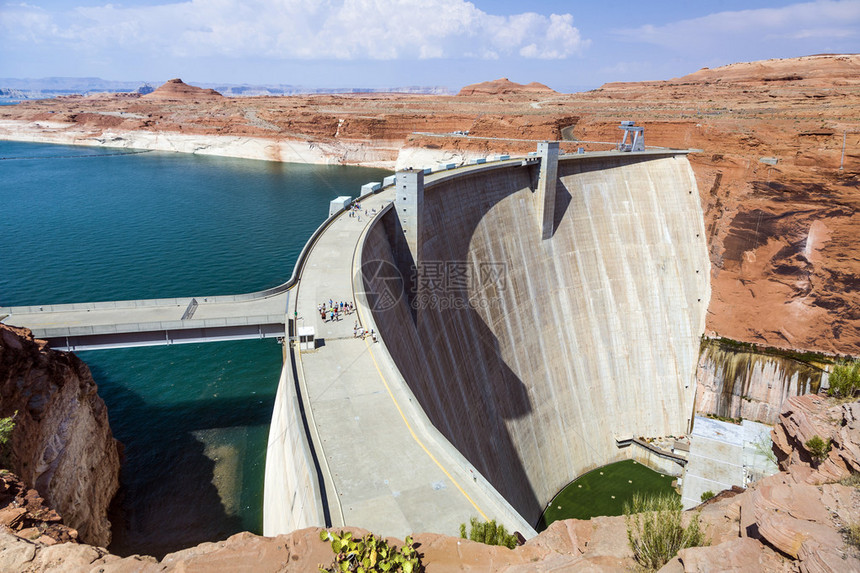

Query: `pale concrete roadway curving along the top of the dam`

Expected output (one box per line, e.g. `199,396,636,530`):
296,189,534,538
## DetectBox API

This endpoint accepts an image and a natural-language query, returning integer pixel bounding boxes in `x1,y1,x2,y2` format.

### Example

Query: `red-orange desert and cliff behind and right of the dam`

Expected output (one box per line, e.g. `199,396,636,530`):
0,55,860,355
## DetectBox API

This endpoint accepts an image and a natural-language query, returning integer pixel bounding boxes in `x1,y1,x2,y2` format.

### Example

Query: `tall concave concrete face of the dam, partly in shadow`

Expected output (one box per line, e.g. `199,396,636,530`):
361,152,710,523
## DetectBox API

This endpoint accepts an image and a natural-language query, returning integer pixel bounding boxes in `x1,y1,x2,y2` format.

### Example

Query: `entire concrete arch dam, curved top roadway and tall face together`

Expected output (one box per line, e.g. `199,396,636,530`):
264,151,710,537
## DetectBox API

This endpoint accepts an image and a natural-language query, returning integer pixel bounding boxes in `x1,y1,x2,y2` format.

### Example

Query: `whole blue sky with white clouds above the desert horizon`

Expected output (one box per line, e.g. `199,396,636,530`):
0,0,860,92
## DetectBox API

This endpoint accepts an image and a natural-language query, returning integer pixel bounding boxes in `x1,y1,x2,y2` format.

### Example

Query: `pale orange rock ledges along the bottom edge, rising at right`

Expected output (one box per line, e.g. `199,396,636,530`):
0,395,860,573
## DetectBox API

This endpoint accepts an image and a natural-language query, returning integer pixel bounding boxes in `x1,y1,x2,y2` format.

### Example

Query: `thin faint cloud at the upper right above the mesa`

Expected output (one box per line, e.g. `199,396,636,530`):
616,0,860,51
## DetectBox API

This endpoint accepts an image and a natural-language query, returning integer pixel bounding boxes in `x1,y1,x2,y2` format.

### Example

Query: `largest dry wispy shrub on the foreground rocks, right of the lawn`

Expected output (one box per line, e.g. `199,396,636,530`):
624,493,708,571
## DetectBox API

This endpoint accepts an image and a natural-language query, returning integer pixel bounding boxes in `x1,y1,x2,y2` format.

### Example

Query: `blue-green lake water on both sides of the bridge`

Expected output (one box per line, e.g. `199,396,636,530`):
0,141,388,555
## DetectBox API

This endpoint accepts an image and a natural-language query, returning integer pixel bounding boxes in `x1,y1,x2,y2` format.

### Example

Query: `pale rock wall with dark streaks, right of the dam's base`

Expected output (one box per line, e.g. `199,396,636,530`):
696,340,827,426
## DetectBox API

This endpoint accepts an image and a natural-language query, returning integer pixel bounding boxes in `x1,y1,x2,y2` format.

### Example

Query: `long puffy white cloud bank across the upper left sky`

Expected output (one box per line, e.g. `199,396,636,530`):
0,0,588,60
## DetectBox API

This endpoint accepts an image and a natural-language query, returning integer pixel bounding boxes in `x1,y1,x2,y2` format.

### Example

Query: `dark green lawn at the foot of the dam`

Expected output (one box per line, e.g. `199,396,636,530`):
536,460,677,531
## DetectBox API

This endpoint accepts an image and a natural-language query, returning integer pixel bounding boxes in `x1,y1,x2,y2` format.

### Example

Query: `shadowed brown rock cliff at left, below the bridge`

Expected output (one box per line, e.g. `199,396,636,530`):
0,324,120,546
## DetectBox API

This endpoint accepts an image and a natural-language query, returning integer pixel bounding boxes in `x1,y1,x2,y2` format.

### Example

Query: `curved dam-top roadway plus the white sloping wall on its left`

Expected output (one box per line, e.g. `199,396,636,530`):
264,162,535,538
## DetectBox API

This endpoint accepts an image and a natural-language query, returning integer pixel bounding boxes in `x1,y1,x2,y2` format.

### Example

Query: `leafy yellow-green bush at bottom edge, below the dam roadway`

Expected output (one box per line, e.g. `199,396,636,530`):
319,531,421,573
